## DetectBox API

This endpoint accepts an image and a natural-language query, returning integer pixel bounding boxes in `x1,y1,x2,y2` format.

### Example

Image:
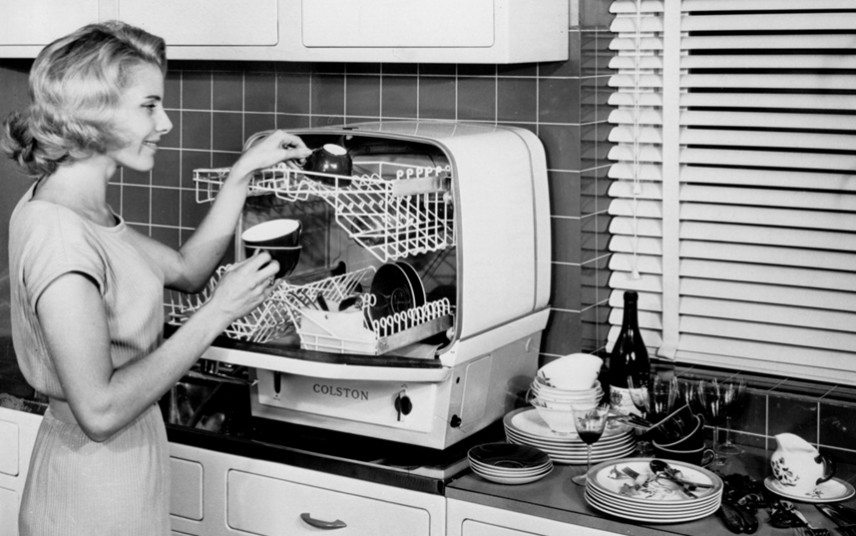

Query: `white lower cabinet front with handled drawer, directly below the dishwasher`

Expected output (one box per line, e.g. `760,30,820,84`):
170,443,445,536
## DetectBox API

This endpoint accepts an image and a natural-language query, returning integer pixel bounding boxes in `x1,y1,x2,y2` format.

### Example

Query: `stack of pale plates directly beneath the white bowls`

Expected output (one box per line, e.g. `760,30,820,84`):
502,408,636,464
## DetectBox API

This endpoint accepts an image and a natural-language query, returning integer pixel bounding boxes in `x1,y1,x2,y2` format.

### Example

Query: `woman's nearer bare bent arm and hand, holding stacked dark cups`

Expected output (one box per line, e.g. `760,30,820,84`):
36,253,278,441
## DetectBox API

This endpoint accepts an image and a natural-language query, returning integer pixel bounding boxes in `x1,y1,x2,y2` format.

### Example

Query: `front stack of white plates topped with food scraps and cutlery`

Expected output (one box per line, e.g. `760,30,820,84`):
585,458,723,523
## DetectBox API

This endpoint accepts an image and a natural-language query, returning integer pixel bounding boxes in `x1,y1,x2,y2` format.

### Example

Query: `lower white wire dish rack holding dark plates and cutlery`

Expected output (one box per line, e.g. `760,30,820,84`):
166,265,453,355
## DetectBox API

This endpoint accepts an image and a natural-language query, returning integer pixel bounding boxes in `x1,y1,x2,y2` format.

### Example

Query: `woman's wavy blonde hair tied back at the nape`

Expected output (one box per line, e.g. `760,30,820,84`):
0,21,166,178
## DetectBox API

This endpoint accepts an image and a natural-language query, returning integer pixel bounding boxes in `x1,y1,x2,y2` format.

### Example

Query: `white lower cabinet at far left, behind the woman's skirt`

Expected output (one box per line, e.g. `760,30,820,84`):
0,408,42,536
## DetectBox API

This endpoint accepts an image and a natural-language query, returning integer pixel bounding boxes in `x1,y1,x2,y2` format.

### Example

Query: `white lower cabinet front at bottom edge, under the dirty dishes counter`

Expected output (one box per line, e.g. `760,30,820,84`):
446,499,617,536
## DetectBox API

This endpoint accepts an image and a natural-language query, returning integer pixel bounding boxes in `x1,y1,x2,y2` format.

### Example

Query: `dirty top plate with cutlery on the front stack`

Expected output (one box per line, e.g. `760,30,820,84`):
586,458,723,507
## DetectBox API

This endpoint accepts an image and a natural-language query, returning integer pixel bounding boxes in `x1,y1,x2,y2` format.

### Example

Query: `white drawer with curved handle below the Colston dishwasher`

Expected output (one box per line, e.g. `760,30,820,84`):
226,470,431,536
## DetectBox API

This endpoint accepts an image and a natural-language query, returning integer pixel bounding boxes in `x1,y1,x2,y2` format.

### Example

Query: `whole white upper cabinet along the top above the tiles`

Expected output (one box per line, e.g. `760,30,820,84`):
0,0,570,63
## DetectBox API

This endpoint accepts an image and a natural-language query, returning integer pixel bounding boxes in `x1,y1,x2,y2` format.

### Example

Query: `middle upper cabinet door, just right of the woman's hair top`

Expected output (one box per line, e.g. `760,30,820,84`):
119,0,278,47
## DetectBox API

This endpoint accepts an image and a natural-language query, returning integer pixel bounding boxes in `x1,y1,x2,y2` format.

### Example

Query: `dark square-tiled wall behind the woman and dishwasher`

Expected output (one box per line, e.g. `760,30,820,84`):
0,0,610,358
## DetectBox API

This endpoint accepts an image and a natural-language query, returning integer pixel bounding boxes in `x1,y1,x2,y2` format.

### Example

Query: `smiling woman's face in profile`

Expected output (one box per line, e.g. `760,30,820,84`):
107,63,172,171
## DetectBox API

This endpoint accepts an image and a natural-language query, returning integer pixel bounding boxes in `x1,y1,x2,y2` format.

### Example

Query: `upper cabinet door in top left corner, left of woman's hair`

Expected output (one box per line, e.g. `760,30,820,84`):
0,0,99,46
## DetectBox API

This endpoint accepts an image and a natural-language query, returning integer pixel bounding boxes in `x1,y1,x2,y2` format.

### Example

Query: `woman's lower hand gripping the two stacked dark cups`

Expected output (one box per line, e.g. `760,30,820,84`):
208,251,279,323
